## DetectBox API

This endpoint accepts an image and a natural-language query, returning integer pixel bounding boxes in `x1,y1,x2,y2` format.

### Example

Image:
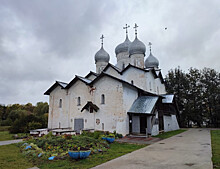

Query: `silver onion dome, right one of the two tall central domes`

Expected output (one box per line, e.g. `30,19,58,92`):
128,37,146,55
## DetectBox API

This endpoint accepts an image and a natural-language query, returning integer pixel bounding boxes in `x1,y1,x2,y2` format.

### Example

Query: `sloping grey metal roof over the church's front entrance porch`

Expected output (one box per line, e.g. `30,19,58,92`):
128,96,159,114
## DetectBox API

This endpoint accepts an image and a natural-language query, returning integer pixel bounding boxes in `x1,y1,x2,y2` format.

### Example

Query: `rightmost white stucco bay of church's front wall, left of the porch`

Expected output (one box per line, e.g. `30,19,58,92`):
90,77,127,134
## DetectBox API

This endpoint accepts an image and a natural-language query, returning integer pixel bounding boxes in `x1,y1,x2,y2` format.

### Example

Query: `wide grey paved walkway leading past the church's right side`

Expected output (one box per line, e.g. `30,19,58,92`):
94,129,212,169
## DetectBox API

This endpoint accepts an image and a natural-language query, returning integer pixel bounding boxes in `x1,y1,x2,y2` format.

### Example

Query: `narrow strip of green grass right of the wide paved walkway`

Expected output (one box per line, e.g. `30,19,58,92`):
211,130,220,169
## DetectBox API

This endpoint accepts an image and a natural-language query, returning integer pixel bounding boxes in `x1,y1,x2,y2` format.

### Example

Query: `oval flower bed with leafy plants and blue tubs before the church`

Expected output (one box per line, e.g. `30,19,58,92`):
20,132,123,160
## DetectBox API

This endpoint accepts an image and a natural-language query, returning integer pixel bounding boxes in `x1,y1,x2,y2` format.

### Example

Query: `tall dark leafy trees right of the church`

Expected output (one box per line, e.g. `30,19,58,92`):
165,67,220,127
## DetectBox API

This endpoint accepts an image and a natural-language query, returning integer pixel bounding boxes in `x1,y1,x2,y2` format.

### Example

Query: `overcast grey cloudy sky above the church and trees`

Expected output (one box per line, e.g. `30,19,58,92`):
0,0,220,104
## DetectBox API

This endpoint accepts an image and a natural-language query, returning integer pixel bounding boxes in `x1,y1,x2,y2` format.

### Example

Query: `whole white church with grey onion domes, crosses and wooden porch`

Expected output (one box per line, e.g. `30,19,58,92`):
44,24,179,135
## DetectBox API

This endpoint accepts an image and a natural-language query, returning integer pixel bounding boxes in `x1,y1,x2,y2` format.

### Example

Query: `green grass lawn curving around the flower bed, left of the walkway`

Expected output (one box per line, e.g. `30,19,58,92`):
0,142,146,169
